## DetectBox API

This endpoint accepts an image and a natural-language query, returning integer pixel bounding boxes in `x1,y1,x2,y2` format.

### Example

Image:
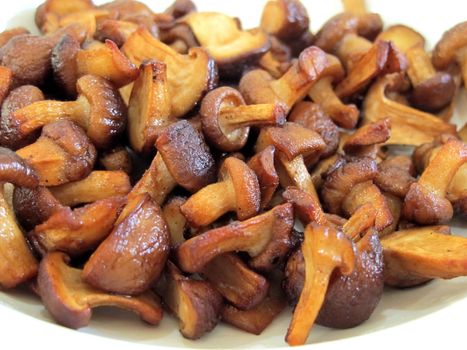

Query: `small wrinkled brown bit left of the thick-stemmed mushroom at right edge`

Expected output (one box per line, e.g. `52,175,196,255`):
373,155,416,198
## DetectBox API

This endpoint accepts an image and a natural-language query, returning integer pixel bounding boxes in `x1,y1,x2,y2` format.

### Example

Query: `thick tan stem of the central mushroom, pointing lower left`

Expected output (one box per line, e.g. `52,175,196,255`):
181,181,236,227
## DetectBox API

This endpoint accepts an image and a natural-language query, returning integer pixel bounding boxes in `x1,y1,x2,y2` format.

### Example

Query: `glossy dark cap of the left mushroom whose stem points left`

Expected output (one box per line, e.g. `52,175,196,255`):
76,75,127,148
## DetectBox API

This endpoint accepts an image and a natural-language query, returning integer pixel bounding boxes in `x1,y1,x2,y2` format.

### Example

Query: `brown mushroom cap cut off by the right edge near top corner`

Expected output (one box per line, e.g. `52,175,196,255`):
432,22,467,69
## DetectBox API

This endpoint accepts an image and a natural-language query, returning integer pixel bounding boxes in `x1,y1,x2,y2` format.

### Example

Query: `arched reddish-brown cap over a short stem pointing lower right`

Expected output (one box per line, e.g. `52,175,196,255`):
321,158,377,215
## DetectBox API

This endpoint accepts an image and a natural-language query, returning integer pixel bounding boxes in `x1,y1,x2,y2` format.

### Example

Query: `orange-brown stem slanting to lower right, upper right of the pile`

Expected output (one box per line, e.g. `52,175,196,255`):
308,77,359,128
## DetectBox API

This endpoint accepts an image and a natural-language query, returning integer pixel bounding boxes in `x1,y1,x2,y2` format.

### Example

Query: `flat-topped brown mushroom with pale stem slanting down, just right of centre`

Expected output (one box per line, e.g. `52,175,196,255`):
255,122,325,198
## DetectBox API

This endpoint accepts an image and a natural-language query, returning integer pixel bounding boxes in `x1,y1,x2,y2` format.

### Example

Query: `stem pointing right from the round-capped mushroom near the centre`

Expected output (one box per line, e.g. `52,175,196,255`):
219,103,284,131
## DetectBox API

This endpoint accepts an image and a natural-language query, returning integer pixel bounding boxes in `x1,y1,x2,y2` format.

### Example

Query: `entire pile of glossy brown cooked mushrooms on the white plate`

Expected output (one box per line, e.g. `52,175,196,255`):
0,0,467,345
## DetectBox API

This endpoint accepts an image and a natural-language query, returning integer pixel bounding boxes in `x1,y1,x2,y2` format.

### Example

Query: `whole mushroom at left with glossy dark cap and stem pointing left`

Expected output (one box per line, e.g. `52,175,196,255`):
12,75,127,149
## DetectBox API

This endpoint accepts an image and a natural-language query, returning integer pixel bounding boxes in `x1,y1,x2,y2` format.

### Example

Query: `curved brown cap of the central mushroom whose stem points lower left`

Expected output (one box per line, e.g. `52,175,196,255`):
219,157,261,220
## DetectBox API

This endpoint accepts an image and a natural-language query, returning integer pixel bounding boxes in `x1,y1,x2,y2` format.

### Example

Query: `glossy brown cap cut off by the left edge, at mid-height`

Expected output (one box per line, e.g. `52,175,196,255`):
0,147,39,188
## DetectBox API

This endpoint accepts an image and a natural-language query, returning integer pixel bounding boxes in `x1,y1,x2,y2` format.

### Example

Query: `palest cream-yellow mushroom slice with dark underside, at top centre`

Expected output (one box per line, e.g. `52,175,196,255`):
180,12,270,77
